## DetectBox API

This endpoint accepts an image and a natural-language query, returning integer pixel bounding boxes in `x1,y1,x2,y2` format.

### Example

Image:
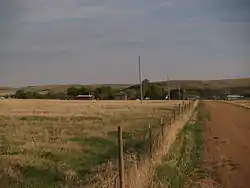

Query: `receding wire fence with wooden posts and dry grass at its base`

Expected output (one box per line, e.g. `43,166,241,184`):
88,100,194,188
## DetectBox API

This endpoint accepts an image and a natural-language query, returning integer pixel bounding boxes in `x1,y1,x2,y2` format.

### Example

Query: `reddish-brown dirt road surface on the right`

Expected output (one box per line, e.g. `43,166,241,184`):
205,101,250,188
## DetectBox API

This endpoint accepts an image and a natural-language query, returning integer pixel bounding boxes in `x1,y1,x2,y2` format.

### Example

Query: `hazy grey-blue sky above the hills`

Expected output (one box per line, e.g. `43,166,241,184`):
0,0,250,87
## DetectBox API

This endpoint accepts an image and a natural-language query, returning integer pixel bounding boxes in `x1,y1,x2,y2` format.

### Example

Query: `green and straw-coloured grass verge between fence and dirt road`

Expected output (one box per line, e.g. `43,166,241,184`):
154,103,210,188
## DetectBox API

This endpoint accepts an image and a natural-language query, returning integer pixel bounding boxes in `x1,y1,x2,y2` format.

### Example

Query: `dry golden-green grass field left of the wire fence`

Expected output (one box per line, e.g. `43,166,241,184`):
0,100,184,188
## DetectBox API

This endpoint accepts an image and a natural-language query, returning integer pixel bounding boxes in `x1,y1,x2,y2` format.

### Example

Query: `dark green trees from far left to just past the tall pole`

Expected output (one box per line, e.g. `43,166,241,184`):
13,79,172,100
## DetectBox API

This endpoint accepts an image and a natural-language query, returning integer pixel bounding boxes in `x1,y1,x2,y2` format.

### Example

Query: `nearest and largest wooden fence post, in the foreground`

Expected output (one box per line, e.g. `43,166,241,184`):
118,126,125,188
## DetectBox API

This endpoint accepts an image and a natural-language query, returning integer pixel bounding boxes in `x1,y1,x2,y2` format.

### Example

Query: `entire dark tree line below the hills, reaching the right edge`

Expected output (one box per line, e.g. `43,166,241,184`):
12,79,249,100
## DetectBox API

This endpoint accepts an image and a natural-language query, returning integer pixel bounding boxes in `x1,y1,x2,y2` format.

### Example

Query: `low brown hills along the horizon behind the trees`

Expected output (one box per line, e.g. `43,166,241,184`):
0,78,250,95
